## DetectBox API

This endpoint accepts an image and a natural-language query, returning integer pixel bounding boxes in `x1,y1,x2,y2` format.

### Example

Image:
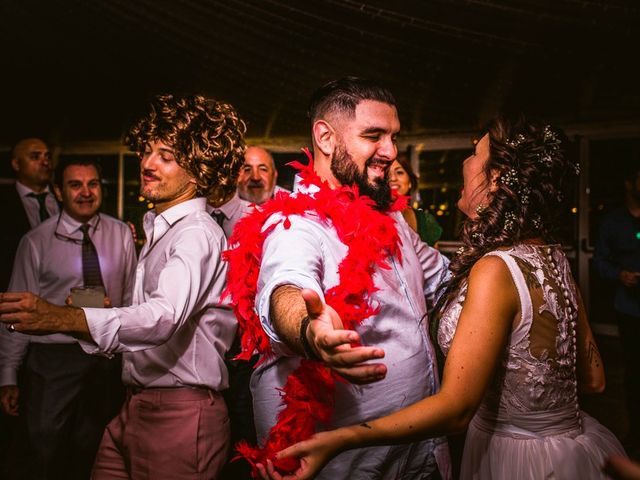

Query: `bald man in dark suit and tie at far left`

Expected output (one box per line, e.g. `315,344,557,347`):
0,138,58,292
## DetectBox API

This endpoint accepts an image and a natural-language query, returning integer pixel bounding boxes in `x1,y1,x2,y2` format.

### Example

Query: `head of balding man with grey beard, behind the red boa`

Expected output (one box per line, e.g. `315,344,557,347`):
238,146,286,205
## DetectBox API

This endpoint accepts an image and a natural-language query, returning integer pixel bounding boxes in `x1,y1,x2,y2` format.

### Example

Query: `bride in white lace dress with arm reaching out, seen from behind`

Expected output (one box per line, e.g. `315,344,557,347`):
260,117,624,480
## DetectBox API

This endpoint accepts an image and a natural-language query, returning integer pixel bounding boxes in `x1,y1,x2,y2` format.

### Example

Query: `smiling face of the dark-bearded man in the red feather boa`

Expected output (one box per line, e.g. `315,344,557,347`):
331,100,400,208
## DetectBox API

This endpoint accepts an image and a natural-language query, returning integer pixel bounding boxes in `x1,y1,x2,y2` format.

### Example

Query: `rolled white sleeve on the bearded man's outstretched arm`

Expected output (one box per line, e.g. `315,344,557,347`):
256,214,325,344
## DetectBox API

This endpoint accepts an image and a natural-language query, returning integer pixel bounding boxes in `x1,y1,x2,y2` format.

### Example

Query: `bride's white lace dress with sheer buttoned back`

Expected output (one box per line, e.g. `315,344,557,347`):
438,245,624,480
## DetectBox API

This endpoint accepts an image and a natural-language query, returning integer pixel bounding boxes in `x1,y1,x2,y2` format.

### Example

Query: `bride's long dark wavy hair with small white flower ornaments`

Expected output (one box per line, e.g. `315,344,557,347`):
438,115,578,307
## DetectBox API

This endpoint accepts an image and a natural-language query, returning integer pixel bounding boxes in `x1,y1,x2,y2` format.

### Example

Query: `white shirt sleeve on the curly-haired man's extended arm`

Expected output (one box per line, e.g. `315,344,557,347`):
80,225,226,353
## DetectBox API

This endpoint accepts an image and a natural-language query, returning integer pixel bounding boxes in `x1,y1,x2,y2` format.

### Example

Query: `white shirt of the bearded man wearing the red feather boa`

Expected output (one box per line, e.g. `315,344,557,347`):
251,187,448,480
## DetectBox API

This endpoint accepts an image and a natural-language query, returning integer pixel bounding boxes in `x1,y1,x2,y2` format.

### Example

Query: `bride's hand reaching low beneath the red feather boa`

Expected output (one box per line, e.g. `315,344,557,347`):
257,430,344,480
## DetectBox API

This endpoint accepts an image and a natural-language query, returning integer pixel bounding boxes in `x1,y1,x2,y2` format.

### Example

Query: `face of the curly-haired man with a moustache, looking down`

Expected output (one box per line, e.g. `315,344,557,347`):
140,141,196,213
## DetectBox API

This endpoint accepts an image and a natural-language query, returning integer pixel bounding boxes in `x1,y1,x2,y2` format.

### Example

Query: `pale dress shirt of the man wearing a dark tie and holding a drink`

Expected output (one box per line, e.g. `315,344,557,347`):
0,211,136,385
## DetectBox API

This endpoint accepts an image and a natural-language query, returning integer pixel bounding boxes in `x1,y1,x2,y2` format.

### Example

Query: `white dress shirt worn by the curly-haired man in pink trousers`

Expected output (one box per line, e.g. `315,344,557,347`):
80,198,237,390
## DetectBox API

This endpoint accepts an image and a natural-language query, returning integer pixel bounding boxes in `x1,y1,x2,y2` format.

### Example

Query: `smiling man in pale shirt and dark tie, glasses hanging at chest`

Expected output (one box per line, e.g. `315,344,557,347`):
0,158,136,479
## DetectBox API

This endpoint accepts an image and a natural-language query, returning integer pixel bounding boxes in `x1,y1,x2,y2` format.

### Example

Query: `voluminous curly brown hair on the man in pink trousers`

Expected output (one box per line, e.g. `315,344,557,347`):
124,95,246,198
